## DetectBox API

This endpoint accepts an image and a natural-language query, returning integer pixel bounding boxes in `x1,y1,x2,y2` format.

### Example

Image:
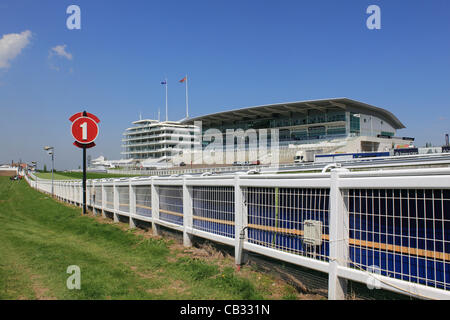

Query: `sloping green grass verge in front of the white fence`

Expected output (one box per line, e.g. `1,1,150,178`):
0,177,292,300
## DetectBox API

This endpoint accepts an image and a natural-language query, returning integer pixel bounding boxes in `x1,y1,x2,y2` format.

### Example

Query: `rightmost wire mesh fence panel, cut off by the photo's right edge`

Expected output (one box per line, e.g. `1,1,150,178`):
344,189,450,290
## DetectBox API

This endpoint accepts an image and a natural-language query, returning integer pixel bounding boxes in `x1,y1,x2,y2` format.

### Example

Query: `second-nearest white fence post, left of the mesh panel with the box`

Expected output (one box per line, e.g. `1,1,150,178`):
234,175,247,266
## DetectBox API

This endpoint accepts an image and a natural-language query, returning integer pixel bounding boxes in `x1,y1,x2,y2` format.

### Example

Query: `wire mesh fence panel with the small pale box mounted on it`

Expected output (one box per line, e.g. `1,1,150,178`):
244,187,329,261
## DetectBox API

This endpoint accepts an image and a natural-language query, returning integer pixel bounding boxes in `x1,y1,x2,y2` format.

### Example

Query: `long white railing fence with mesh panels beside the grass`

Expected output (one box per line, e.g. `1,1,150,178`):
27,168,450,299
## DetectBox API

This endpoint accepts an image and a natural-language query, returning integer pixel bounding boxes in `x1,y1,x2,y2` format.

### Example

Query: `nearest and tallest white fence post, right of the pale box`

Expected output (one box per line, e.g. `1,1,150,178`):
328,169,349,300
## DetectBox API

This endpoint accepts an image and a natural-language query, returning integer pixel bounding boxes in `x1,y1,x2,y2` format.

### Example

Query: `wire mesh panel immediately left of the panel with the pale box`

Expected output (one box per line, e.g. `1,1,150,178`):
192,186,235,238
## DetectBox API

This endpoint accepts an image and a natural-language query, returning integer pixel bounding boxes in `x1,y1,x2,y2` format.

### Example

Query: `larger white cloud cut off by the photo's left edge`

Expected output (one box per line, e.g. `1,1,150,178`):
0,30,31,69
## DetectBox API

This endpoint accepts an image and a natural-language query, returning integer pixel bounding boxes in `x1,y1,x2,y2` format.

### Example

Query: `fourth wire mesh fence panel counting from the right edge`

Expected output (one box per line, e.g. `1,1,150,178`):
158,186,183,225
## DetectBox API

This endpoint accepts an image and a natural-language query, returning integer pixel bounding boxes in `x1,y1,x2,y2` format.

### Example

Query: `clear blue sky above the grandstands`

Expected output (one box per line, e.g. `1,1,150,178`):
0,0,450,169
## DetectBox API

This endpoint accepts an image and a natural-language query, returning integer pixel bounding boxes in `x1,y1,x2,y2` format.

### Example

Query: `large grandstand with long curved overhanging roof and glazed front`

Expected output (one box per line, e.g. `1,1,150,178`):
182,98,414,162
